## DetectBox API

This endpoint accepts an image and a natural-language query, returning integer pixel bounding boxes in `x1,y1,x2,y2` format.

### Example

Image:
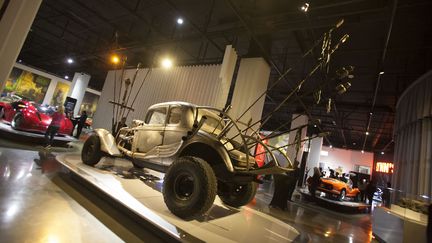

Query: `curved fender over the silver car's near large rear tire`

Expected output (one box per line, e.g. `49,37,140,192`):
179,132,234,172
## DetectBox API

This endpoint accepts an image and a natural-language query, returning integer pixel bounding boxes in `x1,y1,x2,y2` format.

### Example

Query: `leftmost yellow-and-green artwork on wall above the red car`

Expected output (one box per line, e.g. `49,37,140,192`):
2,67,51,103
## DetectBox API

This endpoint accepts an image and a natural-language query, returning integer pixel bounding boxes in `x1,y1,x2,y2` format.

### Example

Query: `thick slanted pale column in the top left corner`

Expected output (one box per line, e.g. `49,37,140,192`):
0,0,42,93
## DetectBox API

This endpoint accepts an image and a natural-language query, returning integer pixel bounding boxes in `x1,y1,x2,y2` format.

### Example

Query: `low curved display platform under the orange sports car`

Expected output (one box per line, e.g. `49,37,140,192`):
299,188,371,213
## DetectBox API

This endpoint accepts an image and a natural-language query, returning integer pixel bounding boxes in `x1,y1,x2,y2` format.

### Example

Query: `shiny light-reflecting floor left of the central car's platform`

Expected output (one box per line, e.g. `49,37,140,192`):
0,145,125,242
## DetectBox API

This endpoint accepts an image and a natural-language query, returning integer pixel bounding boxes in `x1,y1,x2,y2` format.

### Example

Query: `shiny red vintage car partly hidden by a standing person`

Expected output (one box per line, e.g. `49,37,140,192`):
0,100,73,135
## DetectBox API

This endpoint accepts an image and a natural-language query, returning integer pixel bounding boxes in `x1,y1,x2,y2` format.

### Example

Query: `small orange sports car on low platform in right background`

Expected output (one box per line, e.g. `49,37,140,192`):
317,178,360,201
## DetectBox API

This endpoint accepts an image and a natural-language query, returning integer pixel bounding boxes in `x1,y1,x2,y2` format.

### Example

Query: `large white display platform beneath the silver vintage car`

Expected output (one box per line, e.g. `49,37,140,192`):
57,154,299,242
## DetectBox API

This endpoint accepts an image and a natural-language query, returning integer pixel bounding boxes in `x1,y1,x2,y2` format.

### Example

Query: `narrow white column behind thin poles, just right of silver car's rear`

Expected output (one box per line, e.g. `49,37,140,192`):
287,114,308,166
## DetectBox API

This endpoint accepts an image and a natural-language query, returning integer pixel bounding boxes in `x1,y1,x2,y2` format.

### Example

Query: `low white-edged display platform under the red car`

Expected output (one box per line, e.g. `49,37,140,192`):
0,122,78,145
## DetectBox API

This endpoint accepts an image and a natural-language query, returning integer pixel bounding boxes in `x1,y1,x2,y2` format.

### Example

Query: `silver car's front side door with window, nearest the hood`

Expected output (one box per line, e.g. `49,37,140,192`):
132,107,167,154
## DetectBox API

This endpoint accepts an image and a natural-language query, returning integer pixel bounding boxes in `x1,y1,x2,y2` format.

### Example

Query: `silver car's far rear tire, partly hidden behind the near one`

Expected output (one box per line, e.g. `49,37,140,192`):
218,182,257,208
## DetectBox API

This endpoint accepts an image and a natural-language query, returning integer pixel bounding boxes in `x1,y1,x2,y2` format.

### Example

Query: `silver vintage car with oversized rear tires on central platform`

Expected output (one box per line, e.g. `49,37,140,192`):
81,102,290,219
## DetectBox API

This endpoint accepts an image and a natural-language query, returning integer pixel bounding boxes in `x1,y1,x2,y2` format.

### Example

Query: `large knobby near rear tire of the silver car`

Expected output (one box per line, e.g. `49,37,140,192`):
162,156,217,220
